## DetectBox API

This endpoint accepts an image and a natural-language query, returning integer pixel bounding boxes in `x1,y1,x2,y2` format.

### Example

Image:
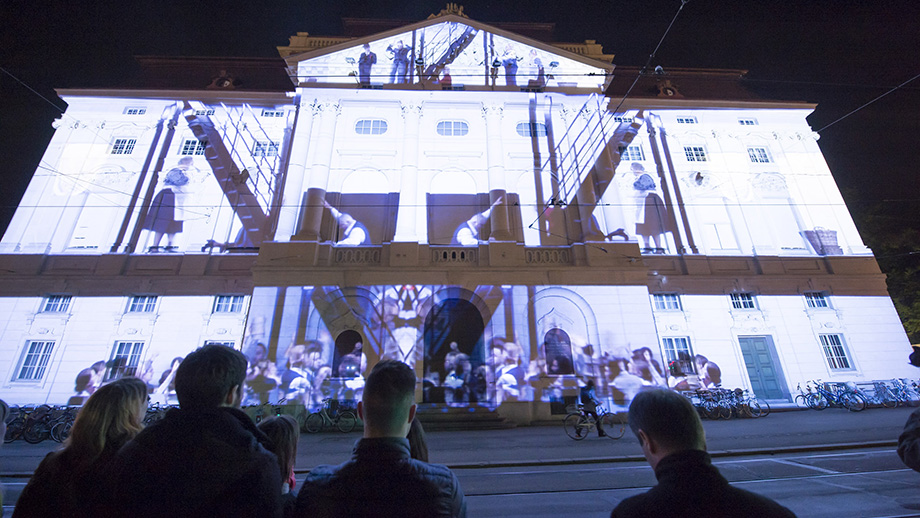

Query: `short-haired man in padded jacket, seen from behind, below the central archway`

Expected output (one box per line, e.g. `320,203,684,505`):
295,360,466,518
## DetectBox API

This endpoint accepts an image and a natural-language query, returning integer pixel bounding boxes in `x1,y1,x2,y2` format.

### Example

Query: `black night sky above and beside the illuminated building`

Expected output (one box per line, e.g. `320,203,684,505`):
0,0,920,242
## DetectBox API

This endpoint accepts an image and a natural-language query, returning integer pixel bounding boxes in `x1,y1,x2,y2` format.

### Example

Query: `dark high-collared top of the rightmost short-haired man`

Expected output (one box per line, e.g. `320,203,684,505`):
610,450,795,518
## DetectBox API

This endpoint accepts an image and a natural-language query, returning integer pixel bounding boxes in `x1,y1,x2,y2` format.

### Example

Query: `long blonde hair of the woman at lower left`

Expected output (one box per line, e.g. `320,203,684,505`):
64,377,147,465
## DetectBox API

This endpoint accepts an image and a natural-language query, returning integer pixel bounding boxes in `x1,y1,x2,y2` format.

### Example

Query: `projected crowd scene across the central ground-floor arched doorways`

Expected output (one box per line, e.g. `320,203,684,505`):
244,285,680,408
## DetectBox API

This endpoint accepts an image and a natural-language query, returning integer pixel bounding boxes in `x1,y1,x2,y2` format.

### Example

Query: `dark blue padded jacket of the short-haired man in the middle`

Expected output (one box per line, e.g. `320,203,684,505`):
294,437,466,518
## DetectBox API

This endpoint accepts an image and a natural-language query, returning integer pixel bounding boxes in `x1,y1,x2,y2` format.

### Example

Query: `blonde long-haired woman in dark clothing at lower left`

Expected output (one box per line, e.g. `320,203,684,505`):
13,377,147,518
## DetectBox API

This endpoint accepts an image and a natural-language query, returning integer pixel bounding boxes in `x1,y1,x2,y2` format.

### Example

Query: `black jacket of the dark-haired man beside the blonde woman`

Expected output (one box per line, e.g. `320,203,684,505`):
108,408,281,518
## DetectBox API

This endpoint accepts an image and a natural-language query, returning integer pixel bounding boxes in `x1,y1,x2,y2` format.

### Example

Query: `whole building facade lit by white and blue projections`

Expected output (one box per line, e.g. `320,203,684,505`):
0,12,912,422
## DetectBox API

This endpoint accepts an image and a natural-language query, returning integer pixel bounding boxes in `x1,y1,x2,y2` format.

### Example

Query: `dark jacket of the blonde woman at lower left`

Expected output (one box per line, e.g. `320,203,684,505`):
13,443,121,518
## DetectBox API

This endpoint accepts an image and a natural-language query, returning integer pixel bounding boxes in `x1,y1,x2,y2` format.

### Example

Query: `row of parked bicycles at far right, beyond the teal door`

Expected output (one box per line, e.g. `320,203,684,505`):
795,379,920,412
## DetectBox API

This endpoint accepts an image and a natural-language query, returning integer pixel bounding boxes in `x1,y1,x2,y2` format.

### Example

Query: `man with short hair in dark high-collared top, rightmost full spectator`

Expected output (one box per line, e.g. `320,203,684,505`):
610,389,795,518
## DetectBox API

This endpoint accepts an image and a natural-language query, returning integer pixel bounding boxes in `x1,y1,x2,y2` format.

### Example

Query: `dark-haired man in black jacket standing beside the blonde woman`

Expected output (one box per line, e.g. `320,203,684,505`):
108,345,281,517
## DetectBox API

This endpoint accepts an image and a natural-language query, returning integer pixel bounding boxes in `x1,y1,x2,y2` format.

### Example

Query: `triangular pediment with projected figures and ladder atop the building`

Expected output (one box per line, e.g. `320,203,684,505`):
285,14,613,89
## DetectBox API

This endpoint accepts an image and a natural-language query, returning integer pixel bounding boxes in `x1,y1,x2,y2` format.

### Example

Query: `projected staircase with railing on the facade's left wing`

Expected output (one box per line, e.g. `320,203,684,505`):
185,102,280,250
